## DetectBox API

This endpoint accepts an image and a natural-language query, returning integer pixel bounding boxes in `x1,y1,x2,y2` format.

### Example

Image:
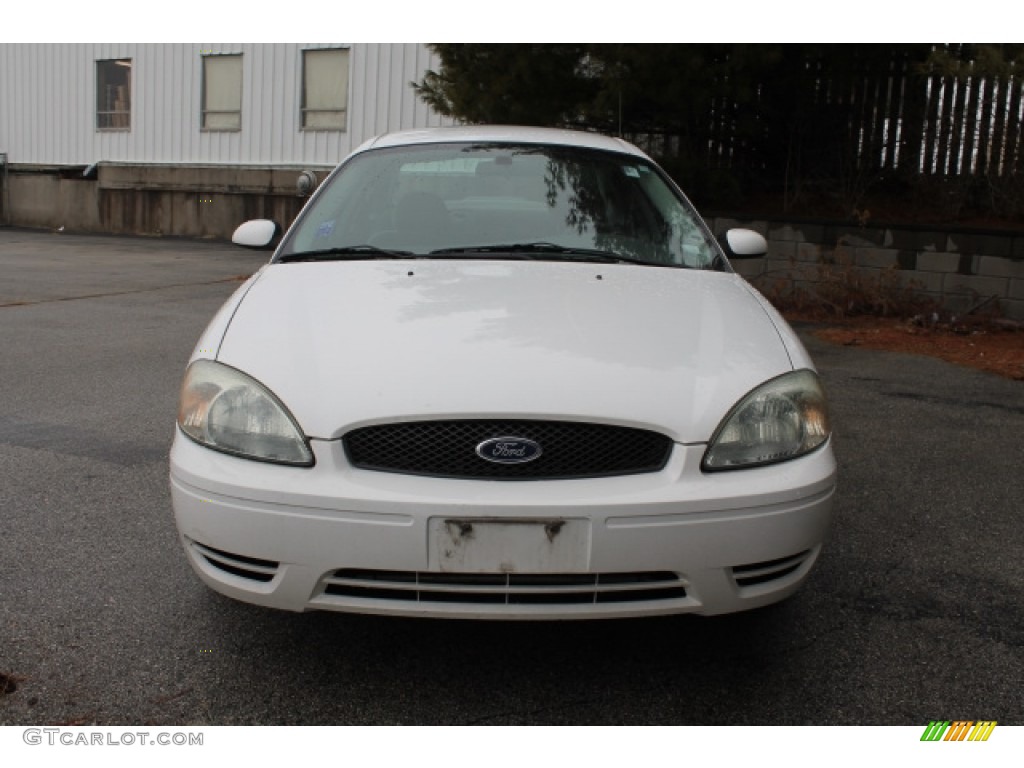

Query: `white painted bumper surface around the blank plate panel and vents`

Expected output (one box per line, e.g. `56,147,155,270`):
171,434,836,618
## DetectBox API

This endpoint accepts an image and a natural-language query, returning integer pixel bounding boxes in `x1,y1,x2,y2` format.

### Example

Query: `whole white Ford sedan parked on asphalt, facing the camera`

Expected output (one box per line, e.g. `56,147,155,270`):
171,127,836,618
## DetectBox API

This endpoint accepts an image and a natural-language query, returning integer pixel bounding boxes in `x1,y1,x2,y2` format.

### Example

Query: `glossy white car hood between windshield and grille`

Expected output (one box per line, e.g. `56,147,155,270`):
217,260,793,442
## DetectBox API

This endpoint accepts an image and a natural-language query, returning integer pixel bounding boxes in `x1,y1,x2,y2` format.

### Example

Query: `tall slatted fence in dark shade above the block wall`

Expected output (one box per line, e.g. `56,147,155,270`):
628,46,1024,185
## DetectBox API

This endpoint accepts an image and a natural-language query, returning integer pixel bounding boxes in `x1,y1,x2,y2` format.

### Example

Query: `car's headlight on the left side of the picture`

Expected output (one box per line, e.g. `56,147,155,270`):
178,360,313,467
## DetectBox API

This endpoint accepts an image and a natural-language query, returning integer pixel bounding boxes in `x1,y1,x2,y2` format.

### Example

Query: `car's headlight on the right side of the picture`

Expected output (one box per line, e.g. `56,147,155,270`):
701,371,830,471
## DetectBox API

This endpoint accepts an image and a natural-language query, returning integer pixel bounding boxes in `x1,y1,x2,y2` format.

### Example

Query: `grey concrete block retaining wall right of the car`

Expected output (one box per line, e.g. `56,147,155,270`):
709,216,1024,321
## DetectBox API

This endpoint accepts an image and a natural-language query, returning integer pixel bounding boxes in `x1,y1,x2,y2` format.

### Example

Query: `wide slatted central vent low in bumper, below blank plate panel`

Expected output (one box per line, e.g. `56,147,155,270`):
324,568,686,605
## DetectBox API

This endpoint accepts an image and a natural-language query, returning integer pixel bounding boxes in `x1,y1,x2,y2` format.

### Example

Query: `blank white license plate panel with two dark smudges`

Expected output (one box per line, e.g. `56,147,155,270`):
429,517,590,573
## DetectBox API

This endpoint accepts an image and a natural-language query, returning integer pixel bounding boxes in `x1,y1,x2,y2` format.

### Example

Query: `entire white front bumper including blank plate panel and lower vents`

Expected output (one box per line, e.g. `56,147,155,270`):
171,433,836,618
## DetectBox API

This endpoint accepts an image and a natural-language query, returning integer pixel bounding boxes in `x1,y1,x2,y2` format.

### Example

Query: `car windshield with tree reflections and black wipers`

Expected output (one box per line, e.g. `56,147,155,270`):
275,143,718,268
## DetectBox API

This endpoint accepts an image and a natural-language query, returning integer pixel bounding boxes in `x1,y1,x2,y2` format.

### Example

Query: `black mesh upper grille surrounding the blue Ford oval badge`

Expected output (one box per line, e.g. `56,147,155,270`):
344,419,672,480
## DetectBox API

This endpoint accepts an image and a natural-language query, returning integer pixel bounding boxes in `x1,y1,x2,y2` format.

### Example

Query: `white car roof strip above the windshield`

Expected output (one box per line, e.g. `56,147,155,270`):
353,125,647,158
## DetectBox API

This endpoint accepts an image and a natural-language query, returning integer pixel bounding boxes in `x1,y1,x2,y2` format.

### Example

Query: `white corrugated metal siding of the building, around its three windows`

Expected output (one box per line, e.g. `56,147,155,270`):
0,43,452,165
